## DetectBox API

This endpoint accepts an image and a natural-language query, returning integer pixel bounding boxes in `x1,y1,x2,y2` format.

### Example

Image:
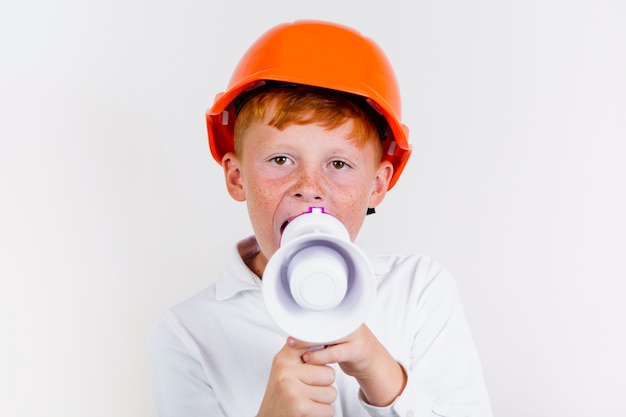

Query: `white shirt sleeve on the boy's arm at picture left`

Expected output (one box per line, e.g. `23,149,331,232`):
148,311,226,417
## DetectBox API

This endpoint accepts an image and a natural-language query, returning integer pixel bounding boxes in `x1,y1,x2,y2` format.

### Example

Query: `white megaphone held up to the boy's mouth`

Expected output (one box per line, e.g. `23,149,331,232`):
262,207,376,345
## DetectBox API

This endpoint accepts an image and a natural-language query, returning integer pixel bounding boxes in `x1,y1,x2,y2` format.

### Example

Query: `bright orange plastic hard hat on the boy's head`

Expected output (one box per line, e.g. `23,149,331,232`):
206,21,411,189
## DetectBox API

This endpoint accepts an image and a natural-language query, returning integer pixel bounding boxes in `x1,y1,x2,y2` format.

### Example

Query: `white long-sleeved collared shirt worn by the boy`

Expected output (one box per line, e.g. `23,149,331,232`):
149,237,492,417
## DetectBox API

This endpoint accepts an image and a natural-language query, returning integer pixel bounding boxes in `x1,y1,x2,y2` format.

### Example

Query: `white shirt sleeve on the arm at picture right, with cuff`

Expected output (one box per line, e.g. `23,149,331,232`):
360,265,492,417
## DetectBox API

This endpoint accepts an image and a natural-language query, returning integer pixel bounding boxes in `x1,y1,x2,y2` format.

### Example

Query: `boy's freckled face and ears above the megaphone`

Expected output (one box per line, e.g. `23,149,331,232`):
223,121,393,272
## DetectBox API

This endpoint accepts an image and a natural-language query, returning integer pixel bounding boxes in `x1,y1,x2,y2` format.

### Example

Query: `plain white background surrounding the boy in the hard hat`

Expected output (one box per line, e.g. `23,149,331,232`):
0,0,626,417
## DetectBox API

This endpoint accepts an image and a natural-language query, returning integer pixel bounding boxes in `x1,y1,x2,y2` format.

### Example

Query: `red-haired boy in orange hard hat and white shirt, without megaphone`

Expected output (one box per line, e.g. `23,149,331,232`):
150,21,491,417
